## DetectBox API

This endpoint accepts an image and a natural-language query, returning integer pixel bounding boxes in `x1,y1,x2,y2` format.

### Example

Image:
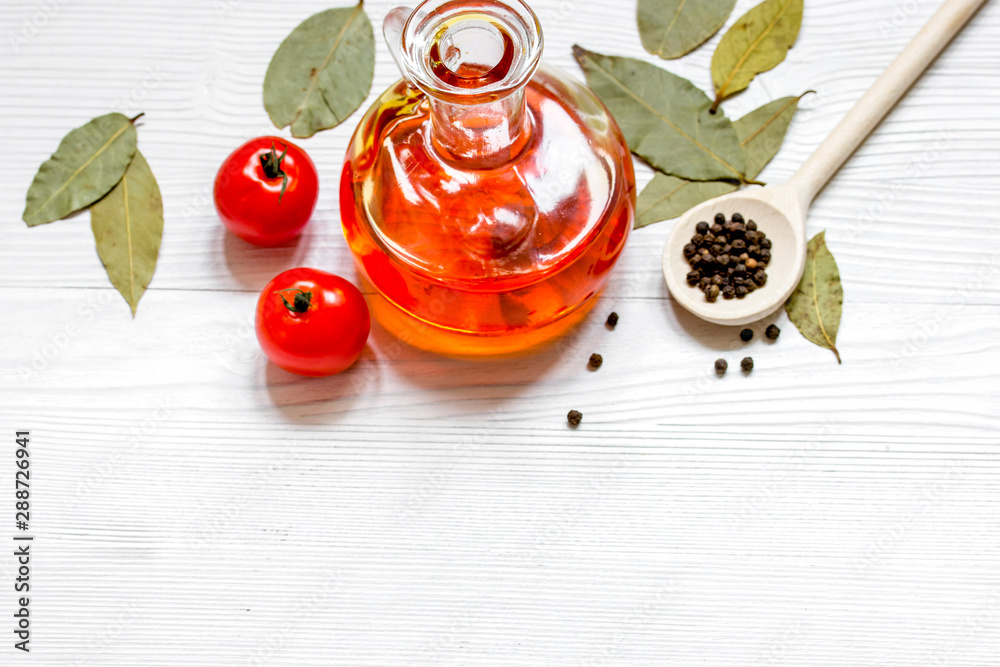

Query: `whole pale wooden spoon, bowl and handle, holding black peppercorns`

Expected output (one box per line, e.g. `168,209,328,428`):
663,0,986,326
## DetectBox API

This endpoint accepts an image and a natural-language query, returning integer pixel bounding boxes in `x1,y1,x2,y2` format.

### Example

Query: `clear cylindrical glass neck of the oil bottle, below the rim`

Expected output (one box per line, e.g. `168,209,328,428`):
428,88,531,169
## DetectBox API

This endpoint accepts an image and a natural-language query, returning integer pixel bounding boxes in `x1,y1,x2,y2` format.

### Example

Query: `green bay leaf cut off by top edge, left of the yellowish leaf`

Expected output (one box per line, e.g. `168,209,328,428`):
638,0,736,60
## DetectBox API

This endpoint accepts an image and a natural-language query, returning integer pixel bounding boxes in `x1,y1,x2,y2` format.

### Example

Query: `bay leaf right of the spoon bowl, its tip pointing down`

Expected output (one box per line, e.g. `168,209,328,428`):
785,232,844,363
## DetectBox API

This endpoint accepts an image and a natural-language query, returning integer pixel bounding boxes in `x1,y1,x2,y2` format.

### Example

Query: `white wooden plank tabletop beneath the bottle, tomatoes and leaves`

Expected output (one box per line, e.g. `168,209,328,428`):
0,0,1000,667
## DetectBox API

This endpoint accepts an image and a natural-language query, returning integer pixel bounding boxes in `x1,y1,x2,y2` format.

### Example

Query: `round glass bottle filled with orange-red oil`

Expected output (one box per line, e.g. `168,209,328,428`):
340,0,635,355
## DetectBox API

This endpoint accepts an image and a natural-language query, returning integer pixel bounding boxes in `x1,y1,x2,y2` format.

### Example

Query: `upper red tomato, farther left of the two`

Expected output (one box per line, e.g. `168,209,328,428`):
215,137,319,247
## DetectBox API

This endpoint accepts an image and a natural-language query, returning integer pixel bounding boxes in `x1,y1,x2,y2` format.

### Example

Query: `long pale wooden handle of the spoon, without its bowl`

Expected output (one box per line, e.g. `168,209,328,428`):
791,0,986,206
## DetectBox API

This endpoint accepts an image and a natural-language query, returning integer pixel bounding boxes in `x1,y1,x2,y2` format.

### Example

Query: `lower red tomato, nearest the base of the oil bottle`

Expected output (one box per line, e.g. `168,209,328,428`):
256,269,371,377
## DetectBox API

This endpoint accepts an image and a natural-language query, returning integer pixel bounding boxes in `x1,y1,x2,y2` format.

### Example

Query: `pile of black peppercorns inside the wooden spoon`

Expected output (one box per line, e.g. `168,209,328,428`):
684,213,771,302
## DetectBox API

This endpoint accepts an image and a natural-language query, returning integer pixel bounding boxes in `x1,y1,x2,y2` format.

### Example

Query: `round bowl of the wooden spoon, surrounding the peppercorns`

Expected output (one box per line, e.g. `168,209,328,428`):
663,183,806,326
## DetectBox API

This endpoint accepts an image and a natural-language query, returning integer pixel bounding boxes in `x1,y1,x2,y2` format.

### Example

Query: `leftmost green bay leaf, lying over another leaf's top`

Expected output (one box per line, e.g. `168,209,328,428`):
22,113,136,227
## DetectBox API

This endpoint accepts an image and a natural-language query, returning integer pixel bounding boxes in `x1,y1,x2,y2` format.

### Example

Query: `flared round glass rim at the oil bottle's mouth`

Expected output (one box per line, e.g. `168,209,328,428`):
400,0,544,104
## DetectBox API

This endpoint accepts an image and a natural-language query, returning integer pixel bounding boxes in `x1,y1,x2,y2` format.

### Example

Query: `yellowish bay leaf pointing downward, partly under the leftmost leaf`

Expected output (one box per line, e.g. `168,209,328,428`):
90,151,163,317
